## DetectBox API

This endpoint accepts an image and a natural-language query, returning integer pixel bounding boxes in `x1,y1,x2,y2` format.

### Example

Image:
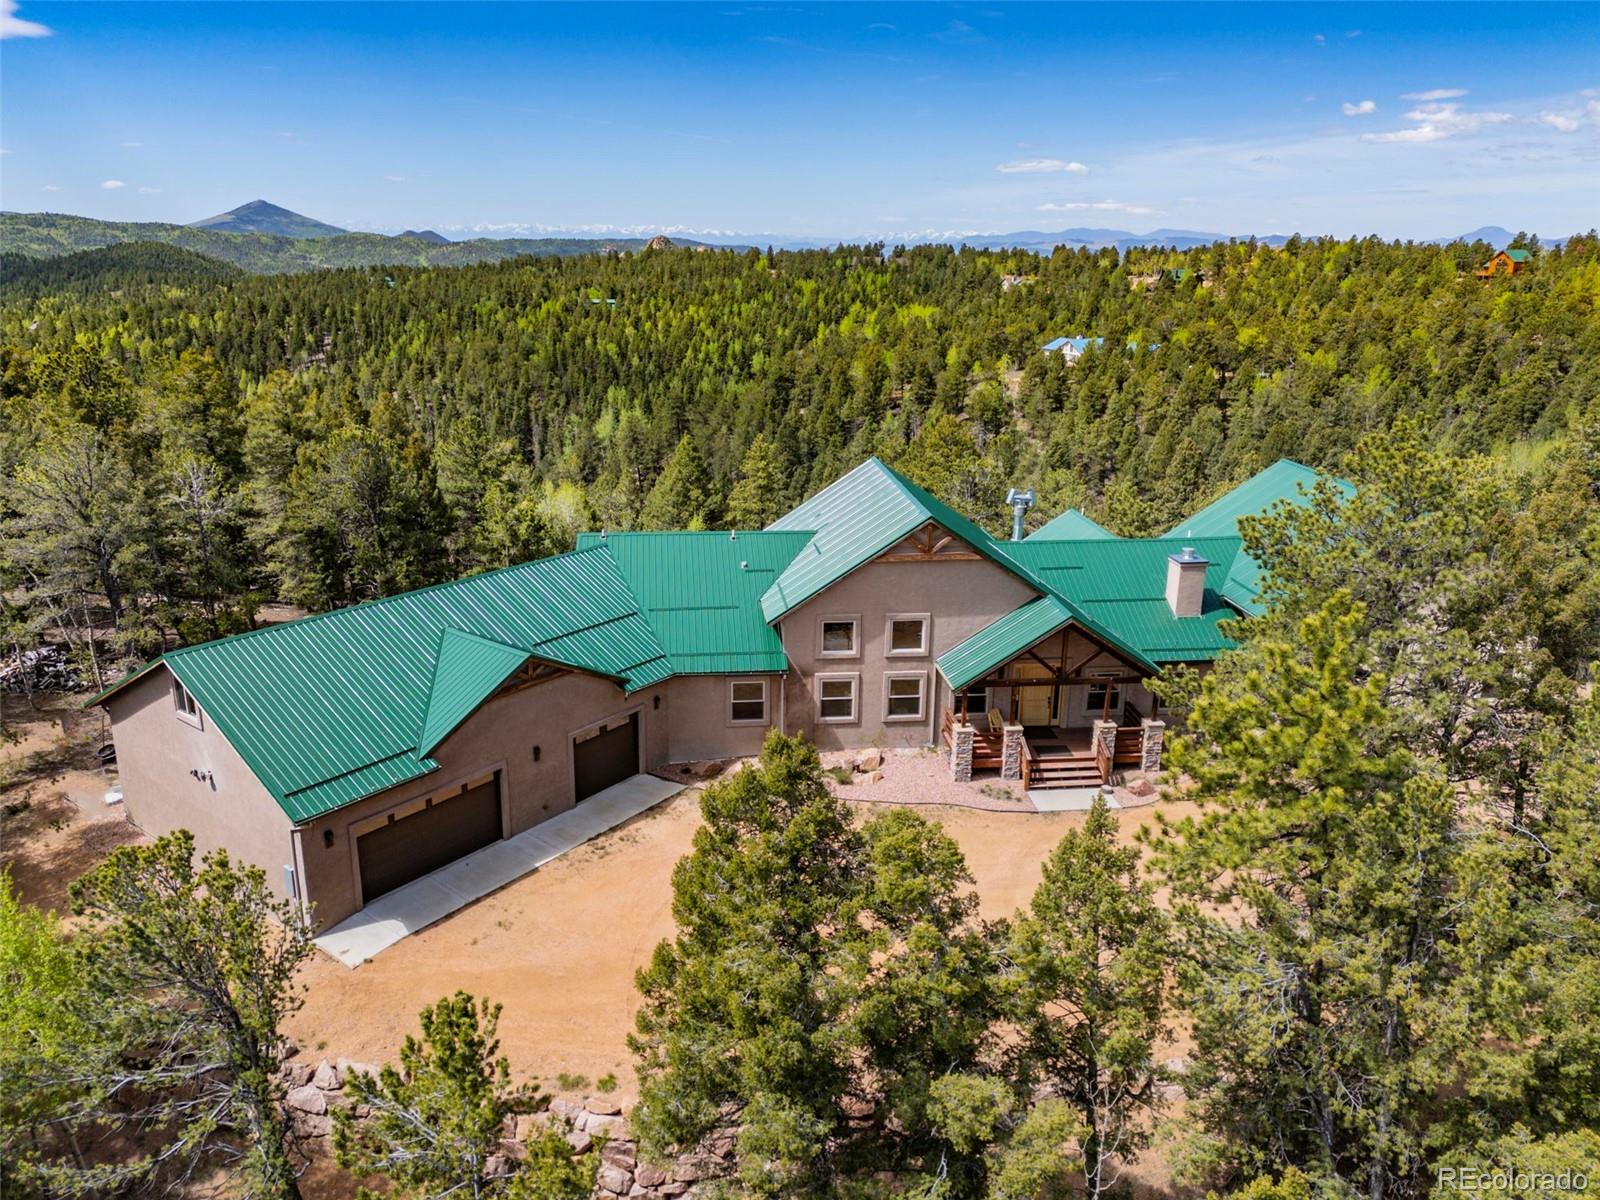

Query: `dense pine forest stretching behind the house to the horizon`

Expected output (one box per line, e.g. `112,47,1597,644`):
0,234,1600,672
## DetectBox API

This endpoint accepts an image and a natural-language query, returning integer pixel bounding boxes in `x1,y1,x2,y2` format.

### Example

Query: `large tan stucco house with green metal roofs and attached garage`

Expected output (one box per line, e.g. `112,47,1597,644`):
93,459,1337,926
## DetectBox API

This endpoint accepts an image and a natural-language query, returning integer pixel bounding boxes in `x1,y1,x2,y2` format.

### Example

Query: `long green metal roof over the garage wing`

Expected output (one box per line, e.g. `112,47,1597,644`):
96,550,670,821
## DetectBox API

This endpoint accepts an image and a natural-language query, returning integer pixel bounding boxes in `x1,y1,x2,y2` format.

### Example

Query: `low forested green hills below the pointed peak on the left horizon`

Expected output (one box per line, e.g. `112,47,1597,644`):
0,213,744,275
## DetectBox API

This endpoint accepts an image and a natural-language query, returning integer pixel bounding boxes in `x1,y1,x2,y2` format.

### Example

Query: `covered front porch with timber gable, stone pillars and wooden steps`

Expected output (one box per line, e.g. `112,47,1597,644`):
939,600,1166,790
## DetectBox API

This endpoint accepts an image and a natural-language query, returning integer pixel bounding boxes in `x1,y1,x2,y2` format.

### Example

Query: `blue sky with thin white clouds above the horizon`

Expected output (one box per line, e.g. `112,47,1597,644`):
0,0,1600,237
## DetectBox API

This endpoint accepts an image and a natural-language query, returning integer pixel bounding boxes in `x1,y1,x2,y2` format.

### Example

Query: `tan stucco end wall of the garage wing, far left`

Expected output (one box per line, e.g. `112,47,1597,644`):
106,667,294,896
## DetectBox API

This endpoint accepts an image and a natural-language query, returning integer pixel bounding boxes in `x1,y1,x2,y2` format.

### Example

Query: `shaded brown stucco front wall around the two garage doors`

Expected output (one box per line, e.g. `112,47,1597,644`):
299,675,670,926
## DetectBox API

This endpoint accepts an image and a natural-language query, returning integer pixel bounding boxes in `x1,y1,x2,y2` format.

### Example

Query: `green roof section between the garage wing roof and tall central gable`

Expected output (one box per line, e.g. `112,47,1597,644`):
578,530,811,675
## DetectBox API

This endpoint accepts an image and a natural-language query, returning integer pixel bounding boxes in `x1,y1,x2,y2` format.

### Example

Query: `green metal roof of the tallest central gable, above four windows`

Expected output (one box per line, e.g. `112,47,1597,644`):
762,458,1043,621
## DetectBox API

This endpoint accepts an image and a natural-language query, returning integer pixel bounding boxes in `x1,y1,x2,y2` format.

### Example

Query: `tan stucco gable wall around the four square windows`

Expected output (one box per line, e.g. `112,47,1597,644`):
781,558,1037,749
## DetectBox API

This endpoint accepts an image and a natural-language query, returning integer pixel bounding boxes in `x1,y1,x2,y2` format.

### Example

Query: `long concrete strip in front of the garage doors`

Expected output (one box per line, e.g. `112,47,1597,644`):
315,774,683,966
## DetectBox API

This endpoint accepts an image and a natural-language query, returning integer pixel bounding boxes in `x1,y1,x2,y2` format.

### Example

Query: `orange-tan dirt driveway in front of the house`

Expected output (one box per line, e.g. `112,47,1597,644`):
290,792,1189,1102
